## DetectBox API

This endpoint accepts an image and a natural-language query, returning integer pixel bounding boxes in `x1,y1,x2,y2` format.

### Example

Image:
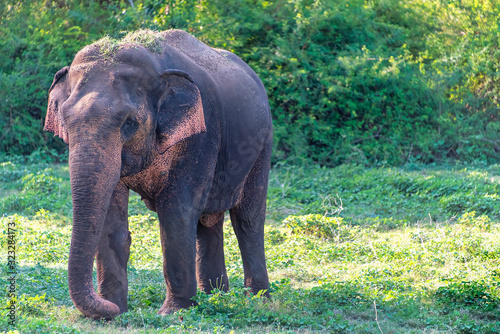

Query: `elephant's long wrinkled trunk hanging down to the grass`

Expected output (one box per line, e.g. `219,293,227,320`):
68,144,121,319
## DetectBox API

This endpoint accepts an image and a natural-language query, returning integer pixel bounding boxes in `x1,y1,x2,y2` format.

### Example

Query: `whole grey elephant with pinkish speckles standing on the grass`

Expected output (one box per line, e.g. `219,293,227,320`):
44,30,273,319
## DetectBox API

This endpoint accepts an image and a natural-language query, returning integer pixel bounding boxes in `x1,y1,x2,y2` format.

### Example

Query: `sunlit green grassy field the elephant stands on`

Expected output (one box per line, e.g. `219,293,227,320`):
0,159,500,333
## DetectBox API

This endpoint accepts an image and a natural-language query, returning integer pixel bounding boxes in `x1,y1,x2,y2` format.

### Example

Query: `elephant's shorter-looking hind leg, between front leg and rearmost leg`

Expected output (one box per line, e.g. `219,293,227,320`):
196,212,229,293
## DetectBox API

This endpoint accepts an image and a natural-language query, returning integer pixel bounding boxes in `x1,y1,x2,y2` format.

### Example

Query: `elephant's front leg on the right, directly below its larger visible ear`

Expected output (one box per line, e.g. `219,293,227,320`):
158,208,198,315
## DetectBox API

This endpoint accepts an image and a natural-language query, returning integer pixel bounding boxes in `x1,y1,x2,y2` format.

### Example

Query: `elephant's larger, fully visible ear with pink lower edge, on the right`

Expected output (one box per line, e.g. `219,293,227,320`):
157,70,207,154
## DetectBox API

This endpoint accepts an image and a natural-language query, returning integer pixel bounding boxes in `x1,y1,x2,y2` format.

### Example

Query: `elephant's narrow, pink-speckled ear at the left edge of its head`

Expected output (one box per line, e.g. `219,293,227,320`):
43,66,70,144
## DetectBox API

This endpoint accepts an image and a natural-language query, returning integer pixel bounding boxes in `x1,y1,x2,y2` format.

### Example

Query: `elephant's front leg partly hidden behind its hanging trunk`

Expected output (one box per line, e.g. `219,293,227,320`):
96,182,131,313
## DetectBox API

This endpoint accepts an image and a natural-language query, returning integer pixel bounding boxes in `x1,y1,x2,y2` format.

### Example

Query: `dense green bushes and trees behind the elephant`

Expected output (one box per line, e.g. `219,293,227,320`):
0,0,500,165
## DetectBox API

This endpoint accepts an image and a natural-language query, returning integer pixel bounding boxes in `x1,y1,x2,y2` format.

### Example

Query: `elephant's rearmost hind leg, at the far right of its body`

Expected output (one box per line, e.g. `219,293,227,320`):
229,147,270,296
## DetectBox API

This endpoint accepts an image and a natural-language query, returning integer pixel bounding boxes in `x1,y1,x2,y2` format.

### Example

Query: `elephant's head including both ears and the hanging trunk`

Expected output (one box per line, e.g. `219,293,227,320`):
45,44,206,318
